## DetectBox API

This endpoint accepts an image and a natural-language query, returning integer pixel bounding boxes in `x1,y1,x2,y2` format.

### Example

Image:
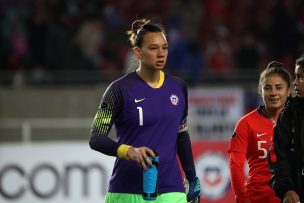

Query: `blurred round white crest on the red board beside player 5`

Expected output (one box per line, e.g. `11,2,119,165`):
195,151,230,200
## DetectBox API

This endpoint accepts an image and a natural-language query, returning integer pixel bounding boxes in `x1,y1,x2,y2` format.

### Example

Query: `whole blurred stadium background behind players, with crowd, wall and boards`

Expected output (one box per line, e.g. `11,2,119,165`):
0,0,304,203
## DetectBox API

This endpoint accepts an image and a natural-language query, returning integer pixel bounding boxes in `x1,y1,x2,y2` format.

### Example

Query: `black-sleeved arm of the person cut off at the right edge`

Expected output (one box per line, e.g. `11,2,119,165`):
268,100,296,198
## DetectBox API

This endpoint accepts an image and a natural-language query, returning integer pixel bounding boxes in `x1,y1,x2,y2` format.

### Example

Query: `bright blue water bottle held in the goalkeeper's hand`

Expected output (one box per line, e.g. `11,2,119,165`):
143,152,159,201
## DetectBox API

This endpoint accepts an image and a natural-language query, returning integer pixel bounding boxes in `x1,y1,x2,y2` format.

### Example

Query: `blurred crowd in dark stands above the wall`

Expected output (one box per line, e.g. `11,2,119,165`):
0,0,304,83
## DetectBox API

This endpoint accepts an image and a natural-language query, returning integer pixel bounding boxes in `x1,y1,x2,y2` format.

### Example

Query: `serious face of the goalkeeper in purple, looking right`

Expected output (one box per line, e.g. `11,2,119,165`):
135,32,168,70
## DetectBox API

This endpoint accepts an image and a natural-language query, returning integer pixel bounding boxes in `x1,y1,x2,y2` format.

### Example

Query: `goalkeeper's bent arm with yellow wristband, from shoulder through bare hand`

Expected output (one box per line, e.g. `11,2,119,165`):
89,83,155,170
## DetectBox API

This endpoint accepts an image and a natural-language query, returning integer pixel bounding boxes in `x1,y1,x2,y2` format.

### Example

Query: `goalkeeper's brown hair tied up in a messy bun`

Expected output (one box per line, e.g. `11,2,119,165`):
127,18,165,47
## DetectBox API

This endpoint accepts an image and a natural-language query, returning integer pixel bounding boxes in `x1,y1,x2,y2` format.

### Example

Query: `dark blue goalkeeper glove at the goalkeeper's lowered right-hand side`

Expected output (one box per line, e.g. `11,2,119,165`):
185,177,201,203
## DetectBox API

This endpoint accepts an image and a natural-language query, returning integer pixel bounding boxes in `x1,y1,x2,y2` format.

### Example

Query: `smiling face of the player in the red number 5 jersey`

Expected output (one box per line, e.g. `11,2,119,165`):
262,74,290,110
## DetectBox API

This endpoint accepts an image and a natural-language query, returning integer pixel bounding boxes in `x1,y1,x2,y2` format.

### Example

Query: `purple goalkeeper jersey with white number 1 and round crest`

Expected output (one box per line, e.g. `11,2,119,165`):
91,72,188,194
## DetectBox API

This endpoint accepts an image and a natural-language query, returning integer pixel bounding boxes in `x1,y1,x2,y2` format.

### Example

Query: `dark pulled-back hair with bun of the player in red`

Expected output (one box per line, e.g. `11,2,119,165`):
258,61,292,93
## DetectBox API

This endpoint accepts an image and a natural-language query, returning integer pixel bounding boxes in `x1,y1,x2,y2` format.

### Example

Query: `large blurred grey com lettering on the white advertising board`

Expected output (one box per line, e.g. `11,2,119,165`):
0,162,108,199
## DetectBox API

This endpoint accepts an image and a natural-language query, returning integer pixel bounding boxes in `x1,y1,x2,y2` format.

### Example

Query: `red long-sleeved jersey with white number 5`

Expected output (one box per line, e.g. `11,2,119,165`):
228,107,280,203
